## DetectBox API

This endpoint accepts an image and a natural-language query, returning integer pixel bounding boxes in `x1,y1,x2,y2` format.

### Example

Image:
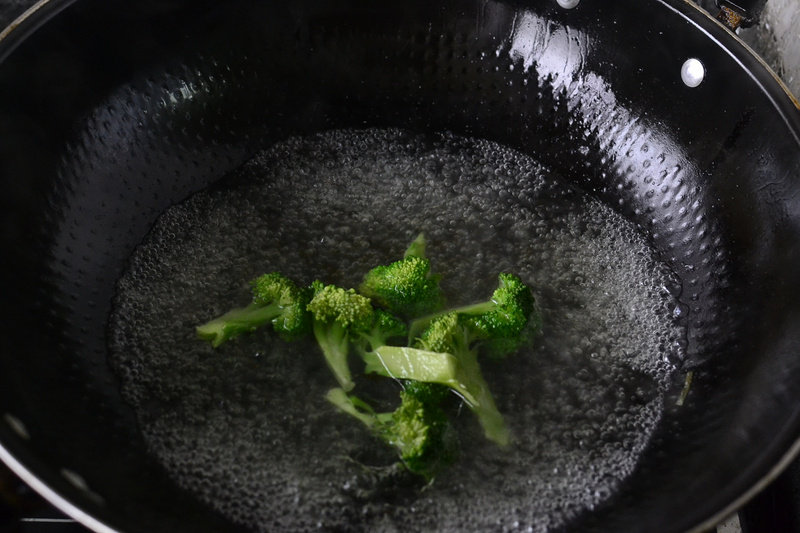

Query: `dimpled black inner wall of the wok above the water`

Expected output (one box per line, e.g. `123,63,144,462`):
0,1,800,531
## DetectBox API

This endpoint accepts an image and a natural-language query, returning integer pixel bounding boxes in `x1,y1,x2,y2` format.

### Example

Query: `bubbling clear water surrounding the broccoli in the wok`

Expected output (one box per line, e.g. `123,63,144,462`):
110,130,685,531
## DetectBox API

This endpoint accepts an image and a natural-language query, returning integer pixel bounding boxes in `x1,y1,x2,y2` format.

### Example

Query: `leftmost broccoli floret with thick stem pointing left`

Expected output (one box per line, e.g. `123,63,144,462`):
197,272,311,348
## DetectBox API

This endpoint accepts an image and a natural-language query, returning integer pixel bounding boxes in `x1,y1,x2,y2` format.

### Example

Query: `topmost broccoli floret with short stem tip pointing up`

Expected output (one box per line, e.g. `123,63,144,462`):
359,234,443,318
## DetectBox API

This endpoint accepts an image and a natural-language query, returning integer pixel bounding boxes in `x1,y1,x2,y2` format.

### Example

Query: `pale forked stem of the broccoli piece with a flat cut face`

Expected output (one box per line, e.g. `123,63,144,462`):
364,346,510,446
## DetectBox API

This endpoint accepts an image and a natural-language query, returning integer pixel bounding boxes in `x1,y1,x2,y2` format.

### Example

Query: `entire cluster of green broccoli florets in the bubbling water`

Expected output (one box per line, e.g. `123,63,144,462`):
197,234,538,481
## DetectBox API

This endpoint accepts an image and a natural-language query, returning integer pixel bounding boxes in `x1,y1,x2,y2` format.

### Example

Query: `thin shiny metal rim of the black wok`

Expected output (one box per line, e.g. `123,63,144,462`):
0,0,800,533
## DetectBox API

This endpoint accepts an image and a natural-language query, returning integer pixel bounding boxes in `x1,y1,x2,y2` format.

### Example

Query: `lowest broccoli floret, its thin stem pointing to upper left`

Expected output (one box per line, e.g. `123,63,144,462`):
327,382,456,481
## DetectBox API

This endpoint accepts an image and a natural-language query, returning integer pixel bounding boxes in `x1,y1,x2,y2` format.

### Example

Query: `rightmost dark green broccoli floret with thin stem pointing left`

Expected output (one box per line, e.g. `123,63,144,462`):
409,273,538,357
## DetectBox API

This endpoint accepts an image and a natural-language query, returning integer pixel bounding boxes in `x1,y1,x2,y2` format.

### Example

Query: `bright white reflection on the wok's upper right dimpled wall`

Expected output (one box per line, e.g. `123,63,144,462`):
495,4,726,370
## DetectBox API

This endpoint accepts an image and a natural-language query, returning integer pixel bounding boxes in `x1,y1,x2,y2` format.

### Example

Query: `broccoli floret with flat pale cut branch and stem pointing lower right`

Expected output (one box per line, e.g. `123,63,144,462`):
365,313,510,446
